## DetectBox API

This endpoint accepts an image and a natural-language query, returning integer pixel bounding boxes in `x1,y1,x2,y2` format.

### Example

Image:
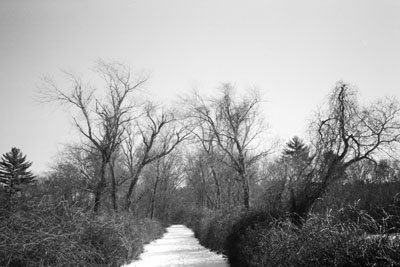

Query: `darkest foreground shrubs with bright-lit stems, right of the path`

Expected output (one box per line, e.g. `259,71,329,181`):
227,210,400,267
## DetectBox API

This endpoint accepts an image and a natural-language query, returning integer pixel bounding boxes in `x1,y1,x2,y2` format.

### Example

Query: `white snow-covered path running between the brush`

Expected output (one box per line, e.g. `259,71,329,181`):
123,225,228,267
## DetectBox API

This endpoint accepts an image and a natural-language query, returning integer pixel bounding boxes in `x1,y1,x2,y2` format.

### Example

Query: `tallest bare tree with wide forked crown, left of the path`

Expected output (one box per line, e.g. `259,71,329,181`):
39,62,146,212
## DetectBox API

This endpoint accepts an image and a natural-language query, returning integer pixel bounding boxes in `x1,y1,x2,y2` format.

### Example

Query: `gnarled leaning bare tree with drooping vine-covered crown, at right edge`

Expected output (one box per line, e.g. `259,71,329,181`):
295,82,400,216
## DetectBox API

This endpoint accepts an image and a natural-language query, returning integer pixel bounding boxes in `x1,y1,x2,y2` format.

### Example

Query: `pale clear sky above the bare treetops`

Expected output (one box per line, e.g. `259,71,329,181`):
0,0,400,175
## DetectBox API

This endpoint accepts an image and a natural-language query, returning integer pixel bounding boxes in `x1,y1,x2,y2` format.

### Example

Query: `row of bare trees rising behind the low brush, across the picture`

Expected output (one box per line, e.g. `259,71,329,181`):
1,61,400,226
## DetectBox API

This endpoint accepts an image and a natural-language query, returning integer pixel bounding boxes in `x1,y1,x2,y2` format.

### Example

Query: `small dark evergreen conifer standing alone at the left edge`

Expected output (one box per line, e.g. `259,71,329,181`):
0,147,35,209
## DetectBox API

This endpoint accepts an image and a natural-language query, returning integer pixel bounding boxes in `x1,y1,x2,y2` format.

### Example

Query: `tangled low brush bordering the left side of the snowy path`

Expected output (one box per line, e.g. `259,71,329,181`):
0,202,164,267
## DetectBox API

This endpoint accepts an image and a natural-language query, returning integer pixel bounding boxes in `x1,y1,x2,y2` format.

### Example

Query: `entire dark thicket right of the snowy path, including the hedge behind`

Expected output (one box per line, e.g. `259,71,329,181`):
185,168,400,267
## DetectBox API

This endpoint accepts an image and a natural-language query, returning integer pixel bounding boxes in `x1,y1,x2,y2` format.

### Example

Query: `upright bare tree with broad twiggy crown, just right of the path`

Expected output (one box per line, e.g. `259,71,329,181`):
185,84,271,208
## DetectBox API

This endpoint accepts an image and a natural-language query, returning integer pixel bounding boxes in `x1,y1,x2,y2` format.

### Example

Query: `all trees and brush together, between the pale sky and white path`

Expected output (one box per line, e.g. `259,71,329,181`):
0,61,400,267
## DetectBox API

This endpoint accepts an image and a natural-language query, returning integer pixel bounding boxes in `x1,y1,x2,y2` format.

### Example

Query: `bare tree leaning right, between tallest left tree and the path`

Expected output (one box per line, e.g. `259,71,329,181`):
123,103,190,210
